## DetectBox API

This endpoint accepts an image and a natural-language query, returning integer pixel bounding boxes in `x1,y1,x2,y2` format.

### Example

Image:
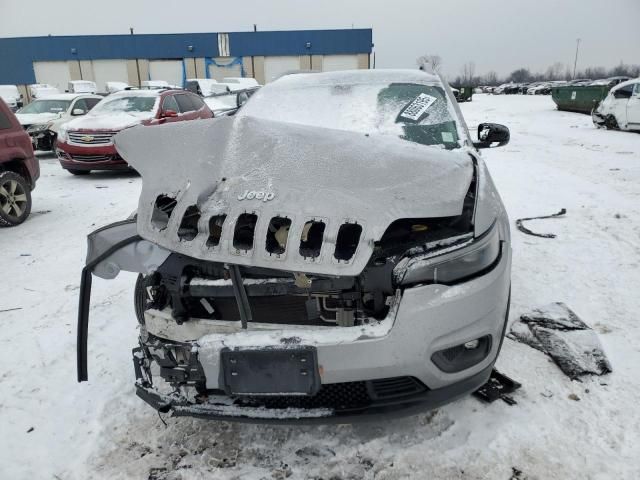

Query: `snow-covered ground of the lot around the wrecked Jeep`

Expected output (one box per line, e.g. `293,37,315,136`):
0,95,640,480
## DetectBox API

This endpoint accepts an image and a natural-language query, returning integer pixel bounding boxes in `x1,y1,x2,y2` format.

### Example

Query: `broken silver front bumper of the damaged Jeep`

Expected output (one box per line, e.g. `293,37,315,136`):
134,246,511,423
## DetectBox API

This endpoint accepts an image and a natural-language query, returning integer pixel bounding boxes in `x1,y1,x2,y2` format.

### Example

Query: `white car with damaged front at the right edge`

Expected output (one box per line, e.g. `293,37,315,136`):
591,78,640,131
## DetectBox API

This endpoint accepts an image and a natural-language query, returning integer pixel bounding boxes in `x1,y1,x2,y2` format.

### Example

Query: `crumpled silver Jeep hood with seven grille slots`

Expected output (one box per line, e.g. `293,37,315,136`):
114,117,473,275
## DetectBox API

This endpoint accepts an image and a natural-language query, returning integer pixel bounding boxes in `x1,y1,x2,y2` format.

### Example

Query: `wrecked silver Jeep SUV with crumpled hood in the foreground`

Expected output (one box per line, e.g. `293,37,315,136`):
78,70,511,422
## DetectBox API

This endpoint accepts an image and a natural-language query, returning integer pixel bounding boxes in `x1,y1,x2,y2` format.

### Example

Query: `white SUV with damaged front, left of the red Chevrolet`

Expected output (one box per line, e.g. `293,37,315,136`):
16,93,102,150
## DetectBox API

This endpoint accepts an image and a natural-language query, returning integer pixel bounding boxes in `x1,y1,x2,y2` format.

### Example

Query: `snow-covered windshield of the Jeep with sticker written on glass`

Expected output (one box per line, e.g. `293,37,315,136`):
241,83,460,148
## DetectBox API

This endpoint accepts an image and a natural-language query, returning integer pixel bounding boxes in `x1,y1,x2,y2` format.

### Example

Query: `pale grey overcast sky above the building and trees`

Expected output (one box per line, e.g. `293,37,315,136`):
0,0,640,76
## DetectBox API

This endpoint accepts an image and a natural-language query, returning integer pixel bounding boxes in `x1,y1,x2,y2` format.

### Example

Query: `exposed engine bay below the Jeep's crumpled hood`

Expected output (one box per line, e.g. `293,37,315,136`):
136,202,474,327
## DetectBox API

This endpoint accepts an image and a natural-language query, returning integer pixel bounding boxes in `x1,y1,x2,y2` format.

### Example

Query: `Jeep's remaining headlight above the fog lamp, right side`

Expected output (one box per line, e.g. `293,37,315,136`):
394,222,501,285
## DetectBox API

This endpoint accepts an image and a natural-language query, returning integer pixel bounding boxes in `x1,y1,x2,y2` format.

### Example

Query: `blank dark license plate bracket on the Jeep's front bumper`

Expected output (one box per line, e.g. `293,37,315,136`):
220,346,320,396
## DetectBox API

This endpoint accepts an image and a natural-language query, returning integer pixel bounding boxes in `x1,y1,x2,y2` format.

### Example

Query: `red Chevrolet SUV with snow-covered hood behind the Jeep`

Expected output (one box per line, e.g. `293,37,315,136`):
56,90,213,175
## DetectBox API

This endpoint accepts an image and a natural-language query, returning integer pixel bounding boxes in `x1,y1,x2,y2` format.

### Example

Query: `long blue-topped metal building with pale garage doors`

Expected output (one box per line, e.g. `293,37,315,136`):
0,29,373,92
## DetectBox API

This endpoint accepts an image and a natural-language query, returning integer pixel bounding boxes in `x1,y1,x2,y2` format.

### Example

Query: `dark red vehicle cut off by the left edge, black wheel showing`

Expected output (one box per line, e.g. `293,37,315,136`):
0,99,40,227
